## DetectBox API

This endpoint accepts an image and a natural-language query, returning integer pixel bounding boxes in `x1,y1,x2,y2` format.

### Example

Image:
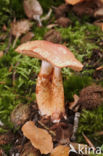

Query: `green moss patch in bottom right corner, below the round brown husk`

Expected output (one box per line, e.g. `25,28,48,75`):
77,105,103,146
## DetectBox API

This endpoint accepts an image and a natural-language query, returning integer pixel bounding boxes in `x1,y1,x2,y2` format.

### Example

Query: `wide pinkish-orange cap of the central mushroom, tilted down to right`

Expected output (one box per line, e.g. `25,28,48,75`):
16,40,83,71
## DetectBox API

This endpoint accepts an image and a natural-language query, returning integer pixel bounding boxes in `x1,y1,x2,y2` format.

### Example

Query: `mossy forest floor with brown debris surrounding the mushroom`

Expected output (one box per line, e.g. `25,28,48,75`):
0,0,103,156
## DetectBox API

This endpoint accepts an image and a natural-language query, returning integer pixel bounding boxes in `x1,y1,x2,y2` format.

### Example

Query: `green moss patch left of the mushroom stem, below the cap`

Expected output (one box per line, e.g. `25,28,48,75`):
0,51,40,127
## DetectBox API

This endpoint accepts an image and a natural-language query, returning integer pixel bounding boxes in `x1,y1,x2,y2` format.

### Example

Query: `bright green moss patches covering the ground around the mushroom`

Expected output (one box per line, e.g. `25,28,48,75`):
0,0,103,154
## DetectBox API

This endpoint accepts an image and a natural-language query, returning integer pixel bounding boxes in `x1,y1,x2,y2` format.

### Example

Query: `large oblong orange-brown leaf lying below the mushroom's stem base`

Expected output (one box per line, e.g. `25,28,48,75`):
22,121,53,154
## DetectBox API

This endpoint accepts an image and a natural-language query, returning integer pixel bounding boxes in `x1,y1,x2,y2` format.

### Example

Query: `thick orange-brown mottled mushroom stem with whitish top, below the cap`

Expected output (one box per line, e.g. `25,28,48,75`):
36,61,65,121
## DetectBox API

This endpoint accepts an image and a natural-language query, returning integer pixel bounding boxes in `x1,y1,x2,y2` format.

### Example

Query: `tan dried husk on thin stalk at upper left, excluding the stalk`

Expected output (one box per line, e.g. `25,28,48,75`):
11,20,32,36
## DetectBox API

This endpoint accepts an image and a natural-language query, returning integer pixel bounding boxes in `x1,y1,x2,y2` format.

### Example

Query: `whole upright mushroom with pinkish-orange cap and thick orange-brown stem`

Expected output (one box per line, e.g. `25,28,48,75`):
16,40,83,122
